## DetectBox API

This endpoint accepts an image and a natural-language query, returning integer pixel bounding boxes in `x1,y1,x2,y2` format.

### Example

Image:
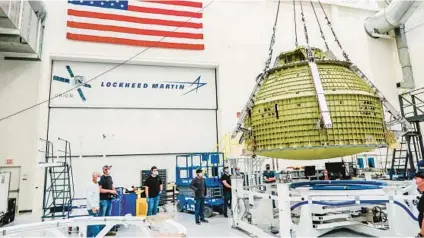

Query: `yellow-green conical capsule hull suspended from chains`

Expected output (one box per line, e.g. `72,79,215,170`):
245,48,387,160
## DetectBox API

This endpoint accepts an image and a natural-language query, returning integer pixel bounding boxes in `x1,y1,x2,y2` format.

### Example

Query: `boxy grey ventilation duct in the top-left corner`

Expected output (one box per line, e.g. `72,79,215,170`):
0,0,46,60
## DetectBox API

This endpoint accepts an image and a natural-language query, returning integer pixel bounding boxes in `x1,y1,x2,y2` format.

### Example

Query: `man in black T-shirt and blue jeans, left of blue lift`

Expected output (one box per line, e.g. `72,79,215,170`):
144,166,163,216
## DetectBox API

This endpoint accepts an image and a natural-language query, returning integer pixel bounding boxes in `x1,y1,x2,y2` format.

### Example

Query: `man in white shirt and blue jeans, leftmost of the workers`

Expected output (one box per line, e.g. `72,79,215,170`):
86,172,100,237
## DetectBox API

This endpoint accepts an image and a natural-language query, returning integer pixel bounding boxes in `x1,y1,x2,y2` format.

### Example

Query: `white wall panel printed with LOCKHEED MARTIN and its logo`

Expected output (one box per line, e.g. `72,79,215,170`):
51,61,217,109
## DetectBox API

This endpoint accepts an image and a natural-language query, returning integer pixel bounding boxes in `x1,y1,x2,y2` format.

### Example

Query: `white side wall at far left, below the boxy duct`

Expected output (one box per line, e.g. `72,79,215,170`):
0,60,41,210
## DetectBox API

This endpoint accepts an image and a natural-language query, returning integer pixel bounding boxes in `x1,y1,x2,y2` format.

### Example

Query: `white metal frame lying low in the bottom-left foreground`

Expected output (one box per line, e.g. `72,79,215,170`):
0,216,187,237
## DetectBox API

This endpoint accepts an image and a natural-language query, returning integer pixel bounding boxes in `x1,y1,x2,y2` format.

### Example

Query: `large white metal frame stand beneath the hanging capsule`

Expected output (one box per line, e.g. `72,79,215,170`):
232,177,419,237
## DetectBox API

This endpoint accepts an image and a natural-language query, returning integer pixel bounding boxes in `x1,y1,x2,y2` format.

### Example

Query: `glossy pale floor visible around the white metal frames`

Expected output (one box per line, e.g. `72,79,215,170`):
3,209,361,237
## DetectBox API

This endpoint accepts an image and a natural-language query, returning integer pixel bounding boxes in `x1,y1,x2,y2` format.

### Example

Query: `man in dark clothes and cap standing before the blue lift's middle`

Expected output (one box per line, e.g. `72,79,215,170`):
190,169,208,225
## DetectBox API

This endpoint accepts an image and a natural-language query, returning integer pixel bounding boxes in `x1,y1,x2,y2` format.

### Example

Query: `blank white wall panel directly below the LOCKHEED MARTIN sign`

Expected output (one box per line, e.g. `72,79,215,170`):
49,108,217,155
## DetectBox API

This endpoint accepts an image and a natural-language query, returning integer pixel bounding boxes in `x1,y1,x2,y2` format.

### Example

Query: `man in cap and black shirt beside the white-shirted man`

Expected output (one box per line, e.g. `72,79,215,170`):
99,165,117,236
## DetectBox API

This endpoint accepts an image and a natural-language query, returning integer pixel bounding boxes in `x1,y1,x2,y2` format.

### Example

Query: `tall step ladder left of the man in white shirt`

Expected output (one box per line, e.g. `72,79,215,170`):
39,138,75,221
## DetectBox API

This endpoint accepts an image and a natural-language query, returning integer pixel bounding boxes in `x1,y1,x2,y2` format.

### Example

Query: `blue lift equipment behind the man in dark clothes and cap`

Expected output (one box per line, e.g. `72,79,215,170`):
176,152,224,217
